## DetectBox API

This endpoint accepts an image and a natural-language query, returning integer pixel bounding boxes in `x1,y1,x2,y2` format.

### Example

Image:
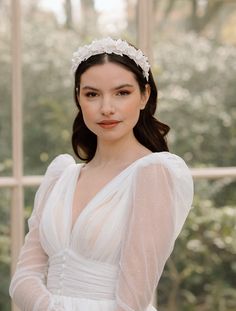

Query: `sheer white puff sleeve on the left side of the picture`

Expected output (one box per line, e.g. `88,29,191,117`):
9,154,74,311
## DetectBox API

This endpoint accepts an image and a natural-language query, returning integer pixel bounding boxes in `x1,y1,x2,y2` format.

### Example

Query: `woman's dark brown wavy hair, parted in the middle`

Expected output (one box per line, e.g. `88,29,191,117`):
72,53,170,162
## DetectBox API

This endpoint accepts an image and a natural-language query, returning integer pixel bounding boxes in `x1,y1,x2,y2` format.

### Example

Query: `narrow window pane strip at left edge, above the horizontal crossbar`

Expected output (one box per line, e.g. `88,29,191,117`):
0,1,12,176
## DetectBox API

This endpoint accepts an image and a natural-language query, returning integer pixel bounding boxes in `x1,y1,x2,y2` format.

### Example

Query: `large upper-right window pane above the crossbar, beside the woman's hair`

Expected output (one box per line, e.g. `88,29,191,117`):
153,0,236,167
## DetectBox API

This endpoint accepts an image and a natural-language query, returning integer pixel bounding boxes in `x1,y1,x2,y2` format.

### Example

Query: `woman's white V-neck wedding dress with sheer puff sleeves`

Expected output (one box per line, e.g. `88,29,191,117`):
10,152,193,311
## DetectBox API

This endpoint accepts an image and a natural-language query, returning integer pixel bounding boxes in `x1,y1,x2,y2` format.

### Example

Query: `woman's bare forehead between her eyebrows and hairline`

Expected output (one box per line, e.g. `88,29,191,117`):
80,63,138,86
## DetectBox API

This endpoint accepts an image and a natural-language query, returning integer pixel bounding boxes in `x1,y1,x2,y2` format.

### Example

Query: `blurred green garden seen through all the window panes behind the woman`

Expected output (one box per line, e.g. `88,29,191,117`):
0,0,236,311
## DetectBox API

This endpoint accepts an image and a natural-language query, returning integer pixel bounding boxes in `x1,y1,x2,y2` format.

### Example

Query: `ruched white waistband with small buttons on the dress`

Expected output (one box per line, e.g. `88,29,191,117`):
47,249,118,299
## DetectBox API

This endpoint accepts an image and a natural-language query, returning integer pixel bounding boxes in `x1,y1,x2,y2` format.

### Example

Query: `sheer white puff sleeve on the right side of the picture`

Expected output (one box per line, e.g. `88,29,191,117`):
116,152,193,311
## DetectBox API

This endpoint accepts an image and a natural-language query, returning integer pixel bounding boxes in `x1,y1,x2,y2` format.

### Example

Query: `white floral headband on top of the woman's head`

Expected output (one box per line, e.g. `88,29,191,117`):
72,37,150,81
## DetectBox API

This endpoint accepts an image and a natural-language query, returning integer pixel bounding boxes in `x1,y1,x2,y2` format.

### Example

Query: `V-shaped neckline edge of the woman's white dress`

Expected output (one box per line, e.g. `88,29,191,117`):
70,153,154,238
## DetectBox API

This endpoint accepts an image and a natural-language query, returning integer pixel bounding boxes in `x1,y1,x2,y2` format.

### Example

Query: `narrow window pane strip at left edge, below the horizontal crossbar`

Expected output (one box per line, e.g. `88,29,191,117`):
0,188,11,310
